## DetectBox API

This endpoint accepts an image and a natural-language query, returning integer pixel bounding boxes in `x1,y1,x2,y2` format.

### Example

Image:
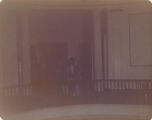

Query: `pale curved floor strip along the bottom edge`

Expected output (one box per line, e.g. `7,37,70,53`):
5,104,152,120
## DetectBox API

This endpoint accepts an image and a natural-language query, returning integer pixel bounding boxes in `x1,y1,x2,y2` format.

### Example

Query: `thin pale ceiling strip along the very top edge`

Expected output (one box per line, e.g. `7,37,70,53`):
3,0,149,5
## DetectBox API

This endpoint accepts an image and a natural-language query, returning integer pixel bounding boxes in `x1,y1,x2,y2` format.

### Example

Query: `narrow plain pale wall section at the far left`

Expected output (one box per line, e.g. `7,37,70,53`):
0,8,18,86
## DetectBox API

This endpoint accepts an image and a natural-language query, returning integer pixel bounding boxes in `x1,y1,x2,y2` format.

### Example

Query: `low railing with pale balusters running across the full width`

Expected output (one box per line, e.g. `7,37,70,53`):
0,80,152,97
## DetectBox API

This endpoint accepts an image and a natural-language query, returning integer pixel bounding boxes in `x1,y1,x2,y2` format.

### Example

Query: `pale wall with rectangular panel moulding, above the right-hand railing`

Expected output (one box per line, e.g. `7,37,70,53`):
108,4,152,80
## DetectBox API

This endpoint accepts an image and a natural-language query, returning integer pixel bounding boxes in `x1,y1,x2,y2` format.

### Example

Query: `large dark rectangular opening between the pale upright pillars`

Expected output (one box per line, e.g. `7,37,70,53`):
25,10,94,94
